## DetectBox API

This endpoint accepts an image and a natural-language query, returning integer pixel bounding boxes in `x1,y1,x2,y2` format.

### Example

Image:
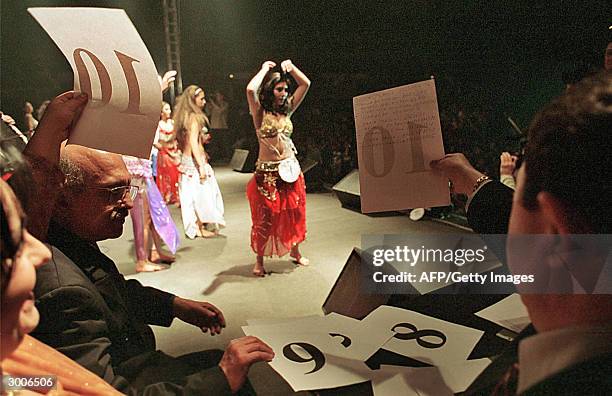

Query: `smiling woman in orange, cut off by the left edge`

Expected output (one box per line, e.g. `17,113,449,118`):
0,180,119,395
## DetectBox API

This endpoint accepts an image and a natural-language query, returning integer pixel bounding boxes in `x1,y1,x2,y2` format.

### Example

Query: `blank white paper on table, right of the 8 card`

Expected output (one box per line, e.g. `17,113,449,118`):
475,293,531,333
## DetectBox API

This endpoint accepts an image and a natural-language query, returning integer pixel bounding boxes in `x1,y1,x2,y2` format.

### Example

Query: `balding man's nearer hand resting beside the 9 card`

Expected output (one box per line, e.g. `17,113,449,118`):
219,336,274,392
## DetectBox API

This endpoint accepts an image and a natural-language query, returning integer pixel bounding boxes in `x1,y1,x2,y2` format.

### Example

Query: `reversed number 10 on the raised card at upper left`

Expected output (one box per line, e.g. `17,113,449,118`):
73,48,144,115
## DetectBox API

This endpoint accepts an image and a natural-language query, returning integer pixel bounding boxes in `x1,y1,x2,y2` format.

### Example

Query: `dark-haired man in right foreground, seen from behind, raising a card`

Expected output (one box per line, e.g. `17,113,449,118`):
432,71,612,395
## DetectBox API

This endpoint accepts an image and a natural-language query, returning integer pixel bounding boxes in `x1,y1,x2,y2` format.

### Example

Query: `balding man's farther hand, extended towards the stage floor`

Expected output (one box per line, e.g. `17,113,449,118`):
173,297,225,335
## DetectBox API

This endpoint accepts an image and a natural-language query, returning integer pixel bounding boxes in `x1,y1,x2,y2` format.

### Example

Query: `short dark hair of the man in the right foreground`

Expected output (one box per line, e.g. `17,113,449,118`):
523,71,612,234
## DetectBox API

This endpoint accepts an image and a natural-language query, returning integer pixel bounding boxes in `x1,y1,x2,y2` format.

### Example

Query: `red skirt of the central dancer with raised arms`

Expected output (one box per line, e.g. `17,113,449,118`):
247,163,306,257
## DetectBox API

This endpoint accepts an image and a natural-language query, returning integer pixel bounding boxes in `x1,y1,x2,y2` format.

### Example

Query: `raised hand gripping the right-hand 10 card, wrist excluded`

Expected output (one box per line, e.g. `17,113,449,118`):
429,153,484,195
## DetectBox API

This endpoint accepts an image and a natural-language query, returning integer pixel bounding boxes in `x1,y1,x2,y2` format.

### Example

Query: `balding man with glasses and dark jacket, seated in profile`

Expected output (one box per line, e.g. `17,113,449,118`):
33,145,274,395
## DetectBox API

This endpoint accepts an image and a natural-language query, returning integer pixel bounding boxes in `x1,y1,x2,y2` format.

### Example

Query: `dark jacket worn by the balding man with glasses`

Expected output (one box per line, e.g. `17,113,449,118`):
32,225,231,395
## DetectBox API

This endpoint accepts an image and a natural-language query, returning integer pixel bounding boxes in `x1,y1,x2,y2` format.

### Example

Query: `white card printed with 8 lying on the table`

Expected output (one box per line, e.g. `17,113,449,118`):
362,305,484,366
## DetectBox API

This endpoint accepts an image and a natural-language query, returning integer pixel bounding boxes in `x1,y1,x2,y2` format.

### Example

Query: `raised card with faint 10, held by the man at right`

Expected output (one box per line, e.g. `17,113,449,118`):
353,80,450,213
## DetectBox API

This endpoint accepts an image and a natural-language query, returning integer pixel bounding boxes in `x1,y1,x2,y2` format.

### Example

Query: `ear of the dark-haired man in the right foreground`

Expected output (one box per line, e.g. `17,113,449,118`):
536,191,585,235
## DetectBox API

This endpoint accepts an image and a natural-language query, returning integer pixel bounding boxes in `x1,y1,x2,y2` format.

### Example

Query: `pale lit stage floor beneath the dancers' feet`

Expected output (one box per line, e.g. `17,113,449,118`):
99,167,458,395
